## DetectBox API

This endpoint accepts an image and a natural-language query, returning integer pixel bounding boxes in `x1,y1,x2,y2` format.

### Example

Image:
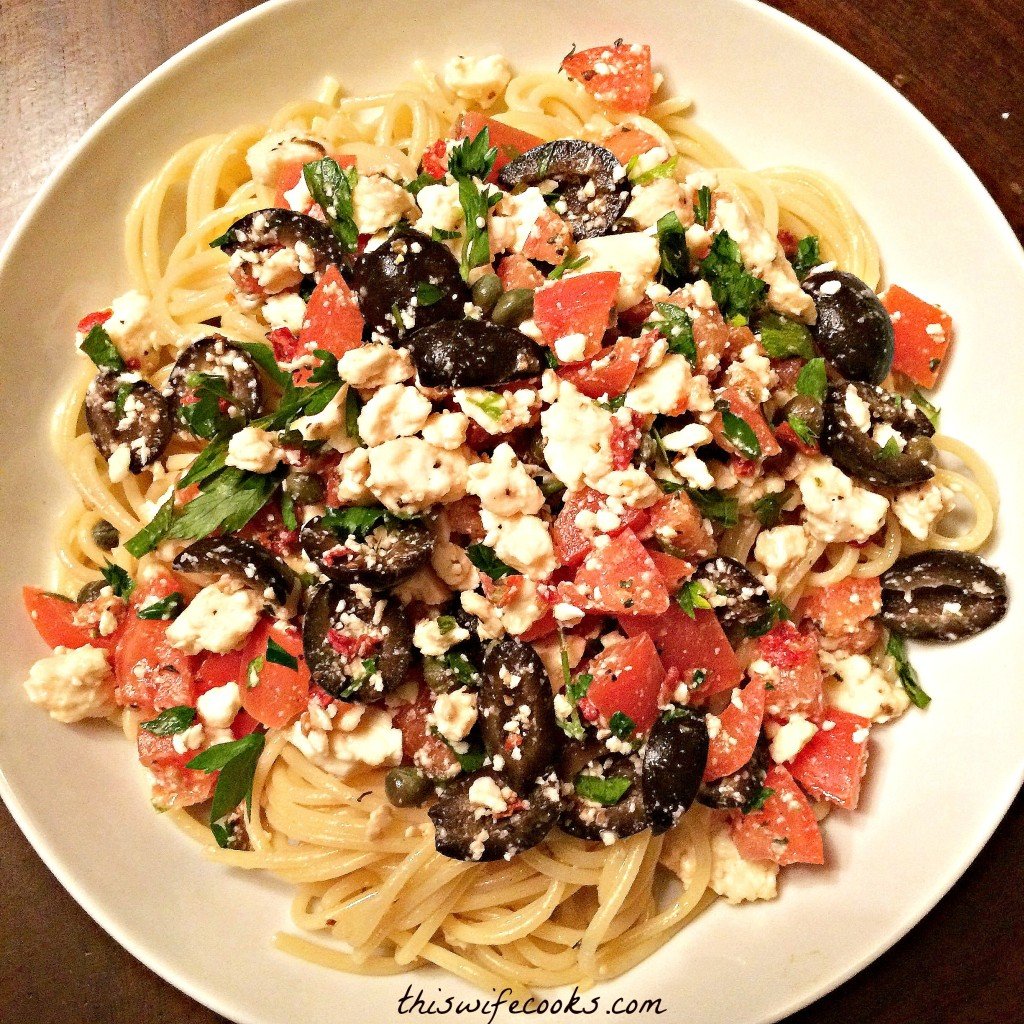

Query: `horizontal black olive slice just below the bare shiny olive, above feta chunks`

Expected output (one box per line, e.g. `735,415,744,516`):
409,319,547,388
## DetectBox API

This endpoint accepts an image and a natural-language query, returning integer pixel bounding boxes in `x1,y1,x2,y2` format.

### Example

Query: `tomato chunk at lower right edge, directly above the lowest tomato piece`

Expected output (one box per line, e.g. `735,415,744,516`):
788,708,871,811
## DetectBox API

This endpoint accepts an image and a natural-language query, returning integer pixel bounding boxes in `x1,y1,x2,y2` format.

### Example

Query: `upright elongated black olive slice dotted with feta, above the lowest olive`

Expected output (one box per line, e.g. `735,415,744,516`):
477,635,562,791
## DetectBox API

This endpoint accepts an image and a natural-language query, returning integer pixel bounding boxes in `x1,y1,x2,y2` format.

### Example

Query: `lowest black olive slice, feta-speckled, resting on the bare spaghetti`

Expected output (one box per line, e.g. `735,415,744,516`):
427,772,559,861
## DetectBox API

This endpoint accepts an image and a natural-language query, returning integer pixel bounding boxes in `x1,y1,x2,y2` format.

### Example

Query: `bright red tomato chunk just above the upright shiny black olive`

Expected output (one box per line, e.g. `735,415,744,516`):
587,633,665,732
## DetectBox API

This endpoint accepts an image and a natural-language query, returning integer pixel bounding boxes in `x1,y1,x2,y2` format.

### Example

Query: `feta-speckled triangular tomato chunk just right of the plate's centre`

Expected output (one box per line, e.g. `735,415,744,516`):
559,529,669,616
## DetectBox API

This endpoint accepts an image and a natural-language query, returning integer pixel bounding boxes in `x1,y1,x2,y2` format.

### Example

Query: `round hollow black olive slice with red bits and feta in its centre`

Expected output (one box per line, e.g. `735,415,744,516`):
302,583,413,702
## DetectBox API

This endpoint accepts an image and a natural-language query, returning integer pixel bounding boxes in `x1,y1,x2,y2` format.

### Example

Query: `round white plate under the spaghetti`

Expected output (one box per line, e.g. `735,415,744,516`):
0,0,1024,1024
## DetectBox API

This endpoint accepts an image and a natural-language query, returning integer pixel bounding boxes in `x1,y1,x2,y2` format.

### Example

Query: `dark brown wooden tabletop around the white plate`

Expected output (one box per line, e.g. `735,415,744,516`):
0,0,1024,1024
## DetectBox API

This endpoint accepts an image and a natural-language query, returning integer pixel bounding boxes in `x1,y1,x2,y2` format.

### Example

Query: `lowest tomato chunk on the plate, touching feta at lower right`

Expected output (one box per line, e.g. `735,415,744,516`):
732,765,825,864
